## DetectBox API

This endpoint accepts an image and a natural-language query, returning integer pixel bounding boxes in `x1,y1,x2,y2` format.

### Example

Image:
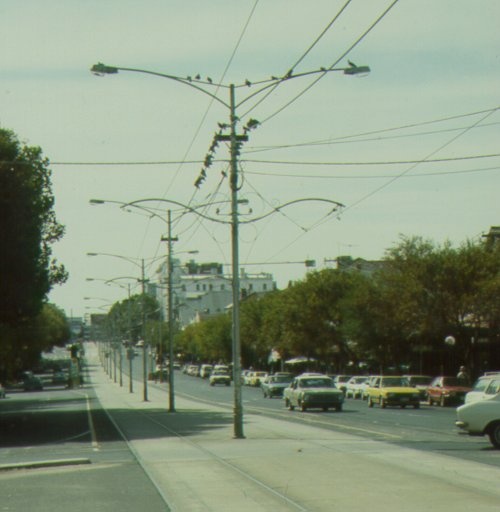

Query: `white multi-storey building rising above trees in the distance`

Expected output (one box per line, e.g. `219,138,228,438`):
156,260,276,326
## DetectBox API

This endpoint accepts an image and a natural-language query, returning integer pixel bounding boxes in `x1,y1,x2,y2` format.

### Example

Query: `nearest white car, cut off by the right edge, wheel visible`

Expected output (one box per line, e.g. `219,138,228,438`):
455,393,500,449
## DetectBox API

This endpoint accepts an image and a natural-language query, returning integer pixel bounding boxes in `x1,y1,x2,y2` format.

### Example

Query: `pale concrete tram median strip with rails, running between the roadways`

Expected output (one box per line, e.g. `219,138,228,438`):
88,346,500,512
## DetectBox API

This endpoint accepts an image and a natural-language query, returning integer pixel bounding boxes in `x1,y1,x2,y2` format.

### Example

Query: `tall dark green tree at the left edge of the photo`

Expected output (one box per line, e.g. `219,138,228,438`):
0,129,67,376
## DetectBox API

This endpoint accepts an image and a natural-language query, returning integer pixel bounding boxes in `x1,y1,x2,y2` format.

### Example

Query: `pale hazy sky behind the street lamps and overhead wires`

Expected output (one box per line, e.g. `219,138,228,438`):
0,0,500,316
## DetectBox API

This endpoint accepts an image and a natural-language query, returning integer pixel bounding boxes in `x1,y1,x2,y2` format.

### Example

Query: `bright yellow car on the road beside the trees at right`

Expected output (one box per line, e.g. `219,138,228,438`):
366,375,420,409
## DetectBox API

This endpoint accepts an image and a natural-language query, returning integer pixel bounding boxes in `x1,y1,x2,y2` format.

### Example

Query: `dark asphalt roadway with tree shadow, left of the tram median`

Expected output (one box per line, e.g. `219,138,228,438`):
0,378,168,512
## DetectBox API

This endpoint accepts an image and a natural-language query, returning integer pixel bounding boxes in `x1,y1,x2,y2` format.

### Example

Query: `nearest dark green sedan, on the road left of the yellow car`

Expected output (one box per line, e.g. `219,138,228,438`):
283,374,344,411
